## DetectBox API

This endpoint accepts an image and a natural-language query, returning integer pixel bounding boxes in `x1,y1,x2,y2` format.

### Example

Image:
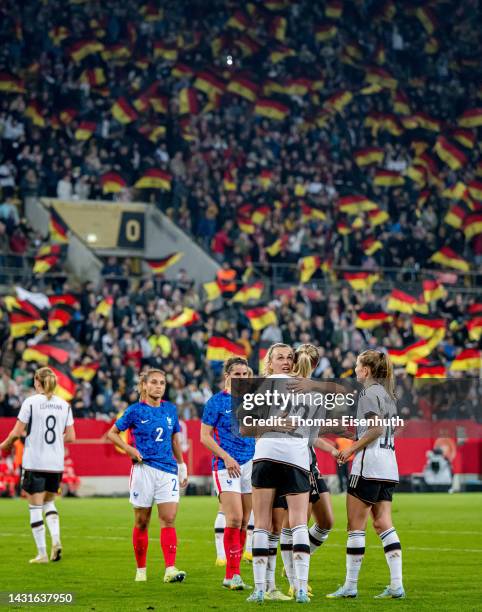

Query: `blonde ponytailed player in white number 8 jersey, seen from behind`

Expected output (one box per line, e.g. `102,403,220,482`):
0,367,75,563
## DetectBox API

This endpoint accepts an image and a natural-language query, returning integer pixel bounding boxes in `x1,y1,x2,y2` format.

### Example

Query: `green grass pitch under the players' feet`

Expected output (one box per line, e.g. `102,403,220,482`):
0,494,482,612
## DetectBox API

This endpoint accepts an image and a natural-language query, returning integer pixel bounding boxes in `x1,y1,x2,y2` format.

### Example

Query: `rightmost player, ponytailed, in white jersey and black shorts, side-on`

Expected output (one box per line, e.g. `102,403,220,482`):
327,350,405,599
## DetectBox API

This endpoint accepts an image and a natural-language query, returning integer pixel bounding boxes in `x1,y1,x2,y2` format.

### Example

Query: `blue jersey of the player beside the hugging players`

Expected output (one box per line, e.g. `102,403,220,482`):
203,391,255,470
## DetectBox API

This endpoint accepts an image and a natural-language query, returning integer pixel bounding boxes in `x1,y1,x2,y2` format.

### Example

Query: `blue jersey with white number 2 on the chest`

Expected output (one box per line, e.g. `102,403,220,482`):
115,401,181,474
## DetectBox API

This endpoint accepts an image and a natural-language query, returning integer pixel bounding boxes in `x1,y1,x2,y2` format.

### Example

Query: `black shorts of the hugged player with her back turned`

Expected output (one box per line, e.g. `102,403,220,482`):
251,459,310,498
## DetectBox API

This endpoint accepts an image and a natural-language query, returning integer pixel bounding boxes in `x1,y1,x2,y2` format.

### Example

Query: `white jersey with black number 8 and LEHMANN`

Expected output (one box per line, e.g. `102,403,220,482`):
17,393,74,472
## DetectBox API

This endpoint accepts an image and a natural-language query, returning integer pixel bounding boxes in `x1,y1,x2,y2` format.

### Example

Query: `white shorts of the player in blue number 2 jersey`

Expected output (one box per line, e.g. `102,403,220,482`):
129,463,179,508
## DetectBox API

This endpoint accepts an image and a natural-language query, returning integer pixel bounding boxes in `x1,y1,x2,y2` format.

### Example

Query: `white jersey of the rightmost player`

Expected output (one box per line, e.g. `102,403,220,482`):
351,383,398,482
